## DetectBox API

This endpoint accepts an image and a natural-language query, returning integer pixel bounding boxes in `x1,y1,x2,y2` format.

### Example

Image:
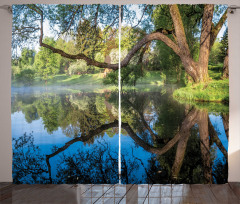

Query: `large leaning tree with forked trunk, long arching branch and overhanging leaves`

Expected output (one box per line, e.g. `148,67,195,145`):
13,4,227,83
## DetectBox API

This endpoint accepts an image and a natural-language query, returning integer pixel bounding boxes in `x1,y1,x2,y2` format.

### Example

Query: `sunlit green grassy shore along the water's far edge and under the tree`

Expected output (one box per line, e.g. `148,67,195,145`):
12,68,229,103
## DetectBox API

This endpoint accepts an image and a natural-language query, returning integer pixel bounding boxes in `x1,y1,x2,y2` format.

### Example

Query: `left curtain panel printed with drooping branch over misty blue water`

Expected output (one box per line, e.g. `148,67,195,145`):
11,4,119,184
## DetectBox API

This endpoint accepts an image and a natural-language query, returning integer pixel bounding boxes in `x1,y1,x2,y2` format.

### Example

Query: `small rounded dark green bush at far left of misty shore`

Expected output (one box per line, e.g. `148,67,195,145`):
16,69,35,86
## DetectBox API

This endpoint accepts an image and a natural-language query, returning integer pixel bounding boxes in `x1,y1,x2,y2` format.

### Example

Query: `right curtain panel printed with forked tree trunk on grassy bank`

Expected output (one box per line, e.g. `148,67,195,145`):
120,4,229,184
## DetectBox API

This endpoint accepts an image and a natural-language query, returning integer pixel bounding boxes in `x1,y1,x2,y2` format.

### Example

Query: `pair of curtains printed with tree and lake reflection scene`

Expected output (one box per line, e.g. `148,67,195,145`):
11,4,229,184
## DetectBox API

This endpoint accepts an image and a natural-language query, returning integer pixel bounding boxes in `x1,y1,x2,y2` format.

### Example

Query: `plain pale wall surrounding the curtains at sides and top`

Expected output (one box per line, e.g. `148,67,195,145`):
0,0,240,182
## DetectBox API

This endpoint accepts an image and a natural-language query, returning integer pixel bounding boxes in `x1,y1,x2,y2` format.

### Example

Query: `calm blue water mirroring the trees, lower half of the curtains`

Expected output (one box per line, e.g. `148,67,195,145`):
12,87,228,184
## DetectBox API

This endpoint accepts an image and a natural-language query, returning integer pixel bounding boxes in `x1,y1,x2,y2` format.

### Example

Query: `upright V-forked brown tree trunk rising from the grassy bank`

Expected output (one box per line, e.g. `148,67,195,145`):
170,4,214,83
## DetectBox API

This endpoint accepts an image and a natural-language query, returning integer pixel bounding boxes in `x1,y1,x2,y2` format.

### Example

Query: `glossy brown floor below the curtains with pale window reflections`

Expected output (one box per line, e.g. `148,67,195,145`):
0,183,240,204
